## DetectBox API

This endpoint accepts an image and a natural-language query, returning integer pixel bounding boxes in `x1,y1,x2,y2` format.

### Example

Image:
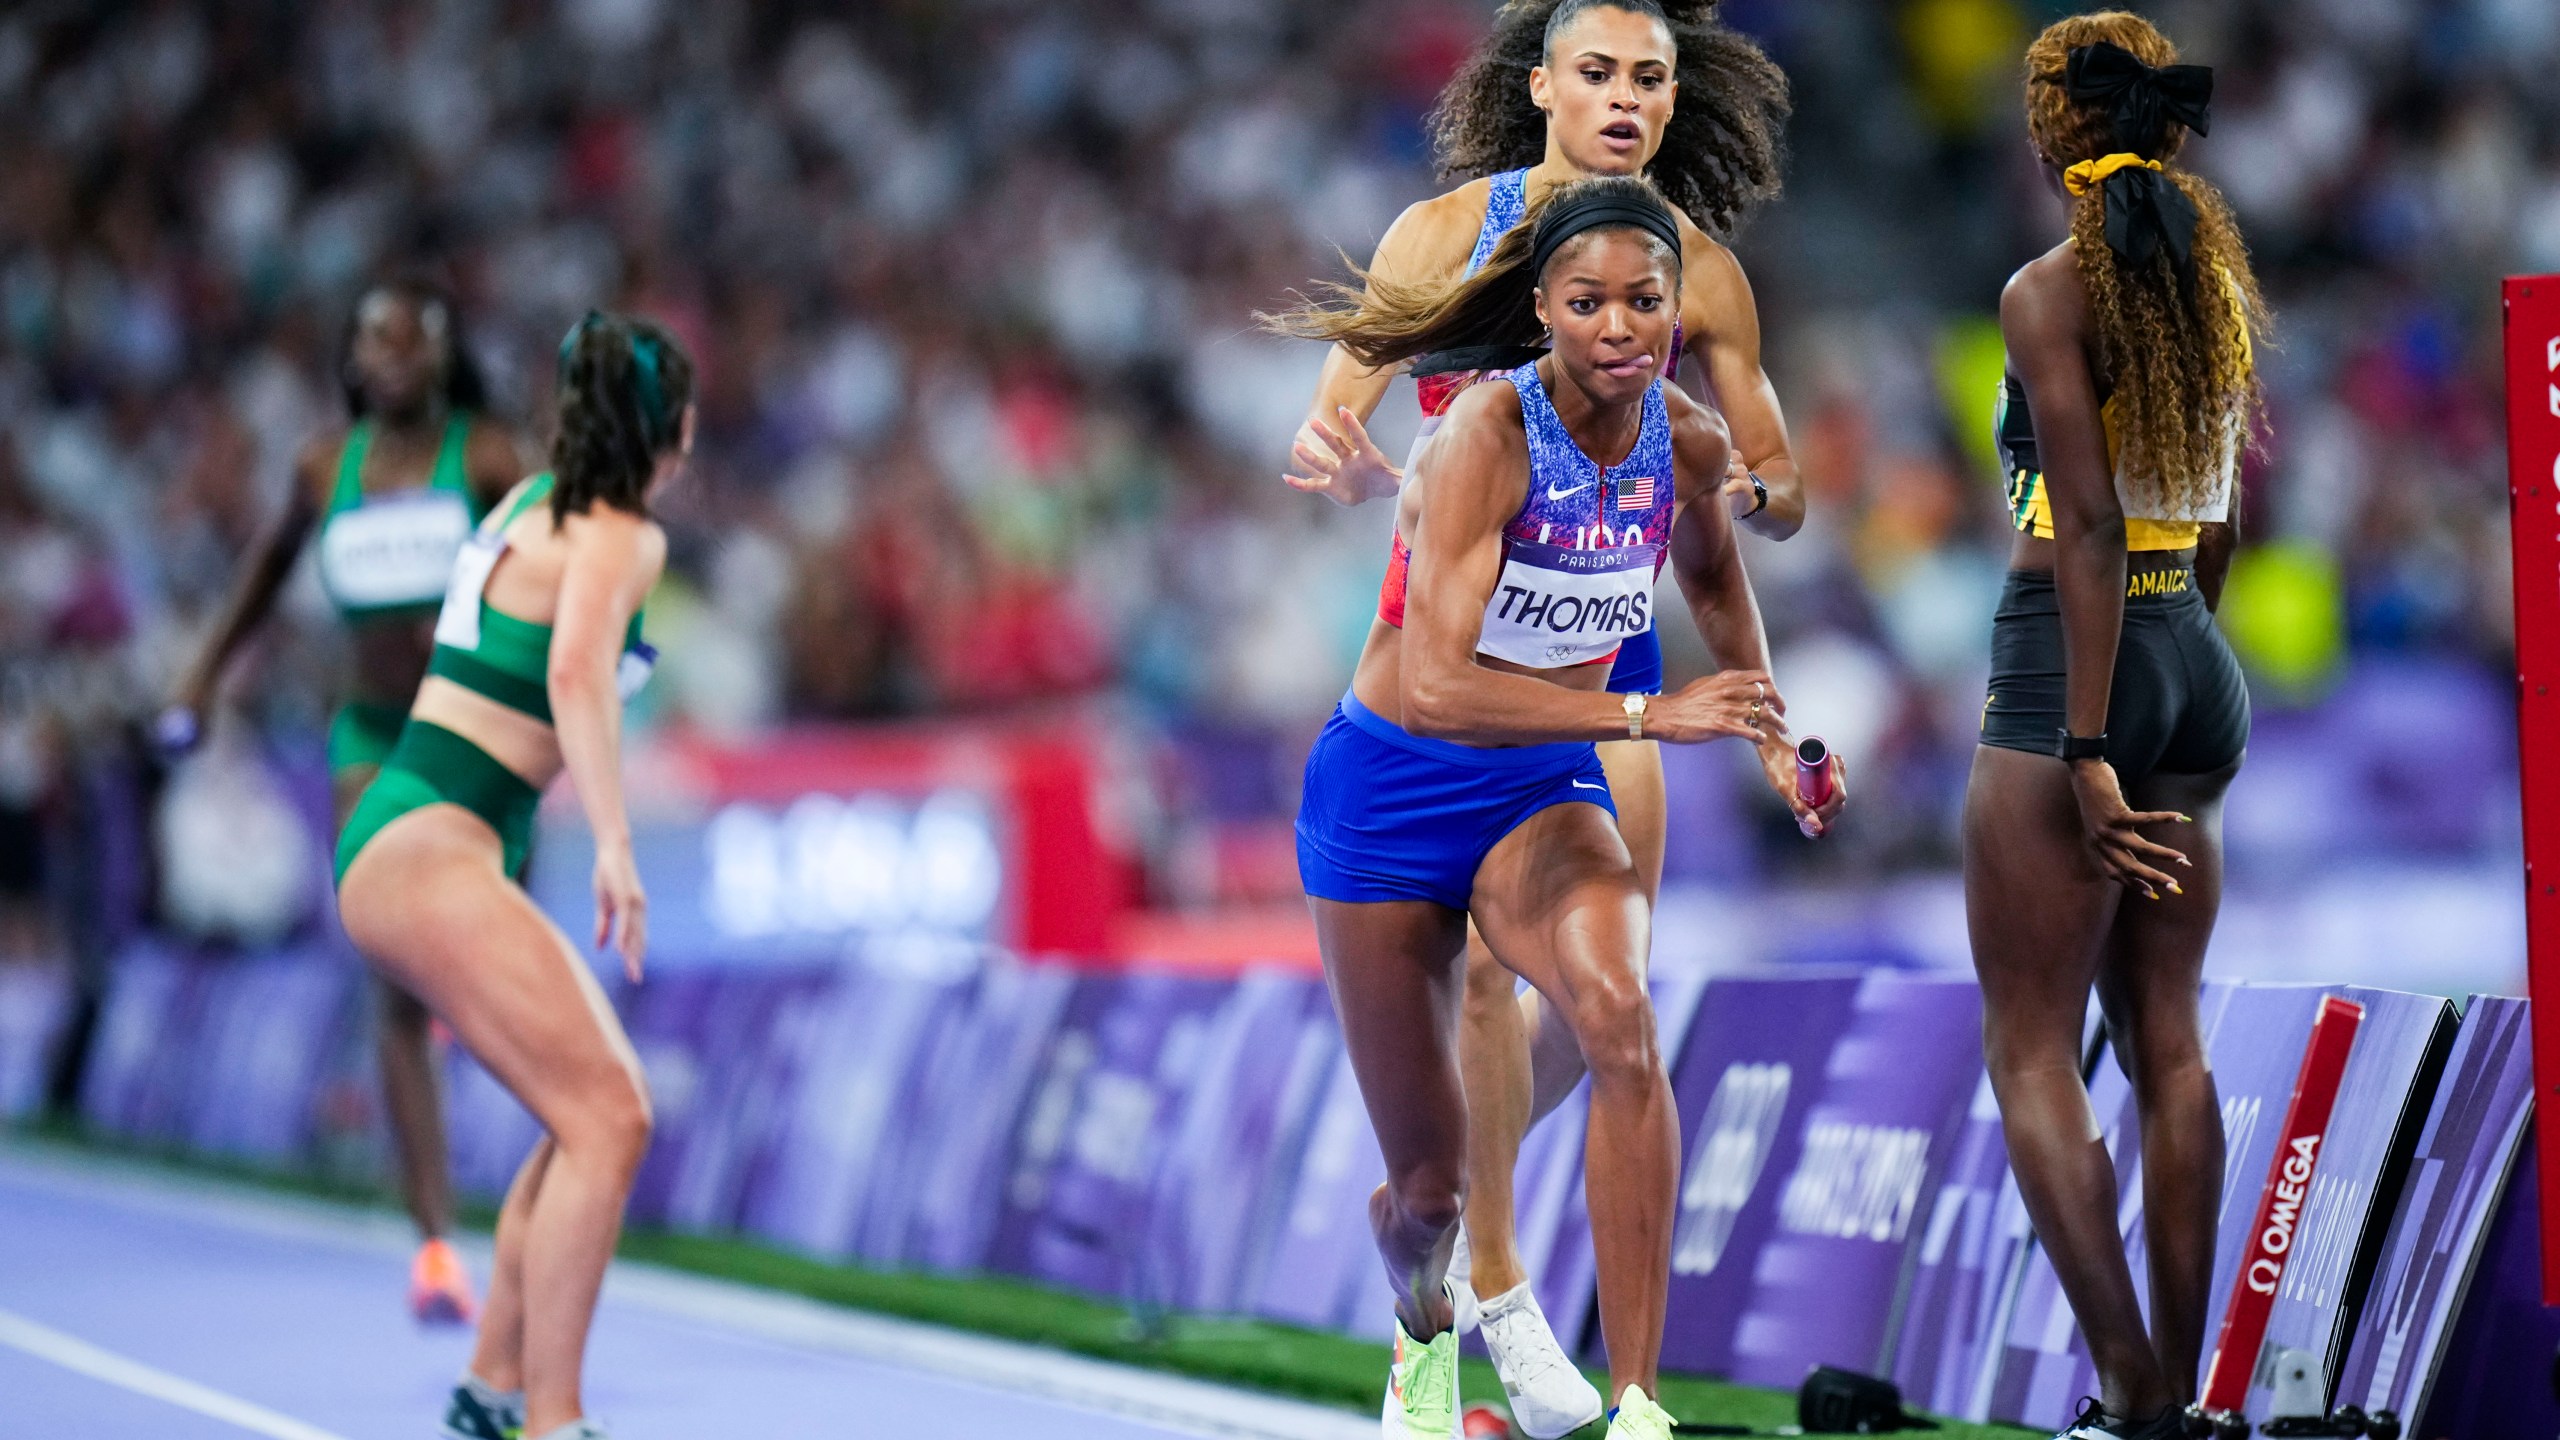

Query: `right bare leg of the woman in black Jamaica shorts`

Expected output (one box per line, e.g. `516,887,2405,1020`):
2097,766,2240,1404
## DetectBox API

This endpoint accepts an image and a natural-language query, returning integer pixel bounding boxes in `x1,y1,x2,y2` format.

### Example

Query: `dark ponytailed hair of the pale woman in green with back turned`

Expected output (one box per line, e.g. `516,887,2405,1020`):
550,310,694,525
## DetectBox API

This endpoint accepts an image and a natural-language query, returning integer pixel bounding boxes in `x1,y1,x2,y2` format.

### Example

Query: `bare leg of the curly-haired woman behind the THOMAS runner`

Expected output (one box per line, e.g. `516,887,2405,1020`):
1459,740,1664,1297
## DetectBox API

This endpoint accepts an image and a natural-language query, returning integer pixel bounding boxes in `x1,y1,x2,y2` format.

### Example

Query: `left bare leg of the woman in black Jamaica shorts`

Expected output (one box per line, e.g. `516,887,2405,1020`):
1964,746,2194,1420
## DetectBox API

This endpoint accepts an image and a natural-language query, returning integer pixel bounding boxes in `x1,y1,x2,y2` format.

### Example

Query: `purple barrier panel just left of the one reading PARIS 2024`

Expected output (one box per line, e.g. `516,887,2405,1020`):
1661,974,1859,1376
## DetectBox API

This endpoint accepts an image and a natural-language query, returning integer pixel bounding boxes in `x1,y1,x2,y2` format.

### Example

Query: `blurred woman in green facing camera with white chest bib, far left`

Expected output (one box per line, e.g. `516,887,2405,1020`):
159,284,525,1322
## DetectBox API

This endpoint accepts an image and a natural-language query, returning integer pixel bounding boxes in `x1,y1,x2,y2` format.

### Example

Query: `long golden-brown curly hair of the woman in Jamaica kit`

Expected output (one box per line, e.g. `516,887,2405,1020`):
2028,10,2268,512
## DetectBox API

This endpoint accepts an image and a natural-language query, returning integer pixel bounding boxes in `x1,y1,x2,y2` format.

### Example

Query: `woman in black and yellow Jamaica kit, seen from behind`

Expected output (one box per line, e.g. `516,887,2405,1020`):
1964,13,2266,1440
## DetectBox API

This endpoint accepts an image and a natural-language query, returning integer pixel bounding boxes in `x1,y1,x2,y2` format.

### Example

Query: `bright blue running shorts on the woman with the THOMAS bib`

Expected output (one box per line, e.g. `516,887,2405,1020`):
1298,694,1618,910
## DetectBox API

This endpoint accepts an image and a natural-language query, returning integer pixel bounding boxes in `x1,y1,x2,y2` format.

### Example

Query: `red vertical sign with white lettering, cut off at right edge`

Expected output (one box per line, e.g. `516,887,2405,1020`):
2506,274,2560,1304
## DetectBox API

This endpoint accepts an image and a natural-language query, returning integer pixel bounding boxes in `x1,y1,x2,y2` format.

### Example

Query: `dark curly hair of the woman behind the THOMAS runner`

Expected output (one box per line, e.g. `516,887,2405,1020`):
1428,0,1795,238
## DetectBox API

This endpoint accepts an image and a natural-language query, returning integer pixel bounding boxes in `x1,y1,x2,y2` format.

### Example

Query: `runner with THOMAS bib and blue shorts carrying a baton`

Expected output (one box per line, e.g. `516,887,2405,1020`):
1275,177,1836,1440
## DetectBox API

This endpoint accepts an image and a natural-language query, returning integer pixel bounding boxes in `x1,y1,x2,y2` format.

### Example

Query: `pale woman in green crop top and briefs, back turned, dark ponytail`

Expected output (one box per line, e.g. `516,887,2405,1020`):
338,315,694,1440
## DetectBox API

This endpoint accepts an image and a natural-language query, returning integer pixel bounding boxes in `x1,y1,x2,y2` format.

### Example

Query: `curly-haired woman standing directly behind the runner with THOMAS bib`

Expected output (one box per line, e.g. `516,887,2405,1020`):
1288,0,1805,1440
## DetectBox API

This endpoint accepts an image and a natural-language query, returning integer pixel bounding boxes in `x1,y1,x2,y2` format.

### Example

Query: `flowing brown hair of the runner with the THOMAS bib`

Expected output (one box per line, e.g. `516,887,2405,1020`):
1257,174,1679,366
